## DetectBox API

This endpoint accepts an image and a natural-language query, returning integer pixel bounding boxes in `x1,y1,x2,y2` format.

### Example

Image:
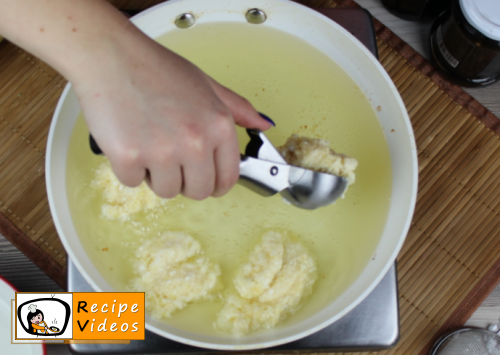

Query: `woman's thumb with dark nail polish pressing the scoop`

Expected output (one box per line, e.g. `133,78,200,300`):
211,79,275,131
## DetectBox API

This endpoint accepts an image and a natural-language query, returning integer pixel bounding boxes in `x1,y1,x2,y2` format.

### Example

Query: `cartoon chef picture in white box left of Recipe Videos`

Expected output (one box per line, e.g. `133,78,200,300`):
16,293,72,339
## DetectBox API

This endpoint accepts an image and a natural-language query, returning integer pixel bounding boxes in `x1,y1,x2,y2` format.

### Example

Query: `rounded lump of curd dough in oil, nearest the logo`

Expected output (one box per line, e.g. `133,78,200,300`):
131,232,220,319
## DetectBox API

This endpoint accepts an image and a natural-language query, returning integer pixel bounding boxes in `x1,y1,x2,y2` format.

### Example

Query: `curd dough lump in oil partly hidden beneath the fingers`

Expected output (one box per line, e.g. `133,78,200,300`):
91,159,167,221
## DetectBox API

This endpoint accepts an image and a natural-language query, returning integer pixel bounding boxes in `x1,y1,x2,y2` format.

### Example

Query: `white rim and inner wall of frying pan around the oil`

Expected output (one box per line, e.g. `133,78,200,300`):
46,0,418,350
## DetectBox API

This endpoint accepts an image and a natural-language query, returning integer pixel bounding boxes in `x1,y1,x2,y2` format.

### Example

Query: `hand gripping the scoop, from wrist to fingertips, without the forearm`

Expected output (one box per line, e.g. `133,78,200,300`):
75,39,270,199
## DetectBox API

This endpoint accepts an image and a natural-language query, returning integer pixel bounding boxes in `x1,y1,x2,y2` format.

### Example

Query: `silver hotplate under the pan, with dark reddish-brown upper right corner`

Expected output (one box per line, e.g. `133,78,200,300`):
68,9,399,355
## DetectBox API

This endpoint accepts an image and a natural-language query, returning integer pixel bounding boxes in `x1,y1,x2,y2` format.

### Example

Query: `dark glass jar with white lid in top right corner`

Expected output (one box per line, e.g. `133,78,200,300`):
430,0,500,86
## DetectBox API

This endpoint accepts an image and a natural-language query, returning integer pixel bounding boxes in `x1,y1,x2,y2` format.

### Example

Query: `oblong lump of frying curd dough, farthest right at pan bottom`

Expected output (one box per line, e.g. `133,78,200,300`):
215,232,316,336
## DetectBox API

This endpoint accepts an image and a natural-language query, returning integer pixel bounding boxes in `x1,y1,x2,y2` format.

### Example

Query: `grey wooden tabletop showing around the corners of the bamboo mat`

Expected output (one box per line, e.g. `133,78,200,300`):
0,0,500,355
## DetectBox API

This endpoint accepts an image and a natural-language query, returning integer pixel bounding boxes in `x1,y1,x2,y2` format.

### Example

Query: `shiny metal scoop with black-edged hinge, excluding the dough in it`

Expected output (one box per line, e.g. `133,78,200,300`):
238,129,347,210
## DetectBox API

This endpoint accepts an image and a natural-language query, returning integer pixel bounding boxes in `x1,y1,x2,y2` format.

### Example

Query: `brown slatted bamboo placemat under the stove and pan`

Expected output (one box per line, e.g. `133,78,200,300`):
0,0,500,355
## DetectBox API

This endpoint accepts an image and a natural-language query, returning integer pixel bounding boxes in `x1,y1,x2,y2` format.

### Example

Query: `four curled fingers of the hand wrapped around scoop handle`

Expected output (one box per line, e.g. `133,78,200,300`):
102,118,239,200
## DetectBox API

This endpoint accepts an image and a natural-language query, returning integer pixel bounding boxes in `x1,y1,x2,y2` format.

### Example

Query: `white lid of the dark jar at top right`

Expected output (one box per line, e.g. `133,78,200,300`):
460,0,500,41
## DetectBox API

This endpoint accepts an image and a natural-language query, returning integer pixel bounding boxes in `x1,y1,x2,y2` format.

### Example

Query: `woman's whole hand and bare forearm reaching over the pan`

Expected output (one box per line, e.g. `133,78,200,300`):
0,0,271,200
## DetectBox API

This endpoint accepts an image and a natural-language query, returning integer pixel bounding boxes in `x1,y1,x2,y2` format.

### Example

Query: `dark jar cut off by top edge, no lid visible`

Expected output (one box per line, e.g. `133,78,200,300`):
382,0,451,22
